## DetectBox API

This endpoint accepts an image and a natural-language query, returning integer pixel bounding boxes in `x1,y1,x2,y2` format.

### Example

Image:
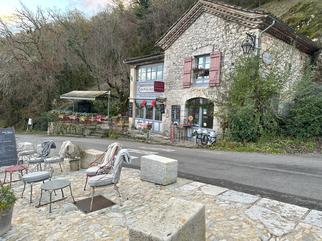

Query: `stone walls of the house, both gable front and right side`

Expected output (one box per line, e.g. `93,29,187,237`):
163,13,308,134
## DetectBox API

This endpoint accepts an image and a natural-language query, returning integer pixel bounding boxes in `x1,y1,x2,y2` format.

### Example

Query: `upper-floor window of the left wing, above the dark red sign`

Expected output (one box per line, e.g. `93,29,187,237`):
138,63,163,81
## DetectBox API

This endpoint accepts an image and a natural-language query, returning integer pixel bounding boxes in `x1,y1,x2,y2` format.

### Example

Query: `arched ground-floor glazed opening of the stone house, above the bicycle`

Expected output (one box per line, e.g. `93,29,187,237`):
187,98,214,129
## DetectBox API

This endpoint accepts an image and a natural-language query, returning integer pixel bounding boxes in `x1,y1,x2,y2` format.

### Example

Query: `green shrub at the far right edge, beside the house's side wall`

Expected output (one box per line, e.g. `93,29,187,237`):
285,68,322,138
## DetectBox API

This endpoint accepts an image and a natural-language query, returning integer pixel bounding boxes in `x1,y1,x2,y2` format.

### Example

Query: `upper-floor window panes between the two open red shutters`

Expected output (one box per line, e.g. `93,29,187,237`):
193,54,210,85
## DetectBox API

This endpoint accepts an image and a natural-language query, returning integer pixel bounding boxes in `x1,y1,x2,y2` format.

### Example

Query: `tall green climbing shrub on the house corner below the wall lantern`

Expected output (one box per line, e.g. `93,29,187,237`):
221,57,284,142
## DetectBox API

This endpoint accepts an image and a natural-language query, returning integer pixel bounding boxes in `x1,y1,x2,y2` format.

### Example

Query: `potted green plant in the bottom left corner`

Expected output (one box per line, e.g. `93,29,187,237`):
0,186,16,236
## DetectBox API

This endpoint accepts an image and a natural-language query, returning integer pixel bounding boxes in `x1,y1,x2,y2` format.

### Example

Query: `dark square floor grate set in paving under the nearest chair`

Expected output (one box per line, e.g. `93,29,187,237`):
75,195,115,213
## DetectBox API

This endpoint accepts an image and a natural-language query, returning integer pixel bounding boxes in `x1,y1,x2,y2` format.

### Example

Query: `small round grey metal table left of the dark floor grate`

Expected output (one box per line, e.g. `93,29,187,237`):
38,179,75,213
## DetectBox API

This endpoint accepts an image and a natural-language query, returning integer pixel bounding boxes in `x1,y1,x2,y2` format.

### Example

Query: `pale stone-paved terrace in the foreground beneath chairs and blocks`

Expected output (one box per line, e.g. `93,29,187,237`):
0,168,322,241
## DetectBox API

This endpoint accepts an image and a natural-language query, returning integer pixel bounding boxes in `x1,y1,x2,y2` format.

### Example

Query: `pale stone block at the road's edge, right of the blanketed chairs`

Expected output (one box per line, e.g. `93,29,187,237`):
141,155,178,185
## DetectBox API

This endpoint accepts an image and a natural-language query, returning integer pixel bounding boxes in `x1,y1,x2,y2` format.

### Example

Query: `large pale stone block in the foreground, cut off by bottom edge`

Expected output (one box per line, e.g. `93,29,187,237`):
129,198,206,241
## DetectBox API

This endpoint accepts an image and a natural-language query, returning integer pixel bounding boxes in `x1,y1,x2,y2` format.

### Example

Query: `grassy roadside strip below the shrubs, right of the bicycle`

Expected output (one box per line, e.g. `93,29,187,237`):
211,138,317,154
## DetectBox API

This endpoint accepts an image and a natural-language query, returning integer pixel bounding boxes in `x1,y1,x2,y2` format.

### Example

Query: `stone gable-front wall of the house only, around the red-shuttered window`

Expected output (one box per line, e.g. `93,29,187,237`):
164,13,257,134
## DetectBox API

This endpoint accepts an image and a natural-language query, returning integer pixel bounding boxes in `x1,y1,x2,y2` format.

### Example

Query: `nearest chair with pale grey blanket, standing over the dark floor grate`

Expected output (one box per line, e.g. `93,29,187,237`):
88,149,131,211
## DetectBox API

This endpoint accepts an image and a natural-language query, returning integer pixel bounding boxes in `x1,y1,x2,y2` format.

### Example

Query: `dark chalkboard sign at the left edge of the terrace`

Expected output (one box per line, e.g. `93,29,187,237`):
0,128,17,167
